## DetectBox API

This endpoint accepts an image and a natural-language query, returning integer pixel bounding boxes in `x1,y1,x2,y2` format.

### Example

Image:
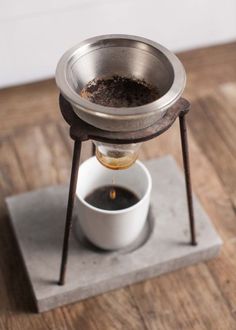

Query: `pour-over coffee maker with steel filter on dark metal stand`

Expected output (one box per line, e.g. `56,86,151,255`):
56,35,196,285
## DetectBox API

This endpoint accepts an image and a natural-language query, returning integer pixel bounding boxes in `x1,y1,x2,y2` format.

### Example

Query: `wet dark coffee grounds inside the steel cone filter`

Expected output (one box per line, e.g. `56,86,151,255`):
80,76,160,108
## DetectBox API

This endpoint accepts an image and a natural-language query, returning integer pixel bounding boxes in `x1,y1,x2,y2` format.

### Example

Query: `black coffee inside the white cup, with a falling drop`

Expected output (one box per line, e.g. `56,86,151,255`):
85,185,139,211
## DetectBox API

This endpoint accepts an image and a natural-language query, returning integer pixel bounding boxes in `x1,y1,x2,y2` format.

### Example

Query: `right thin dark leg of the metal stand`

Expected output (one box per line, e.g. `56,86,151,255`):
179,114,197,245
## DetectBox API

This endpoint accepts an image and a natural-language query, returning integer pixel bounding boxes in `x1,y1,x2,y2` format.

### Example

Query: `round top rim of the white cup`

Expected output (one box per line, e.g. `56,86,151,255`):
76,156,152,215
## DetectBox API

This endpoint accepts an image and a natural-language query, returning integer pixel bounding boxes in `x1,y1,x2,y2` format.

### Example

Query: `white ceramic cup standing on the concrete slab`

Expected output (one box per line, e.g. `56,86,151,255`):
75,157,152,250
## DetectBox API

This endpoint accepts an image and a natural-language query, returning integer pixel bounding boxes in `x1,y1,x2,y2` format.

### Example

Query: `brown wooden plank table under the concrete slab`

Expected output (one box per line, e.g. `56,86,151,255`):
0,43,236,330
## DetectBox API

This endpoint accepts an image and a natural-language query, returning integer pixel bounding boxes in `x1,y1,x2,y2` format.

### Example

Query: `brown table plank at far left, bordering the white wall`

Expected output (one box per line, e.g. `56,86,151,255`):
0,80,61,136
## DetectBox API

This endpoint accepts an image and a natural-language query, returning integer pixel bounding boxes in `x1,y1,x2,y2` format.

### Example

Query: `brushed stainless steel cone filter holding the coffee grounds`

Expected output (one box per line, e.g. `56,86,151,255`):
56,35,186,131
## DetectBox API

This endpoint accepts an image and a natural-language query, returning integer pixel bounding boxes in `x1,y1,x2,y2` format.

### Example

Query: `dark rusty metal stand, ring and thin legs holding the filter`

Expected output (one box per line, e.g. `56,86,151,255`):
59,95,197,285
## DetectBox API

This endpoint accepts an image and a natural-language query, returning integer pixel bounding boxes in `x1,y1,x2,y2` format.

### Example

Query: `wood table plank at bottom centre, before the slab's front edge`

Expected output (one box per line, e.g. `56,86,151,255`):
63,289,148,330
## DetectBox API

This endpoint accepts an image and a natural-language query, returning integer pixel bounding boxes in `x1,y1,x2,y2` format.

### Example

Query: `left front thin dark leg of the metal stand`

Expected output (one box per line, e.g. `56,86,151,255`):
58,140,81,285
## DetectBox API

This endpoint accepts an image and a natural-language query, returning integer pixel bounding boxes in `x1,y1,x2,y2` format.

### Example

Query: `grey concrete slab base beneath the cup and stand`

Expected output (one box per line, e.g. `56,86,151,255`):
7,156,222,312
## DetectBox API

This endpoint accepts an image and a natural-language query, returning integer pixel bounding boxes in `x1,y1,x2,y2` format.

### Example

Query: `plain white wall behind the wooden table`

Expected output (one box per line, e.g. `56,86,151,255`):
0,0,236,87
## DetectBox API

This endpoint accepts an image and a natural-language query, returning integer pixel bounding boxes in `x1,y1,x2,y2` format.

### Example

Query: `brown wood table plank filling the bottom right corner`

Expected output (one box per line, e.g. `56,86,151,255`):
130,264,235,330
